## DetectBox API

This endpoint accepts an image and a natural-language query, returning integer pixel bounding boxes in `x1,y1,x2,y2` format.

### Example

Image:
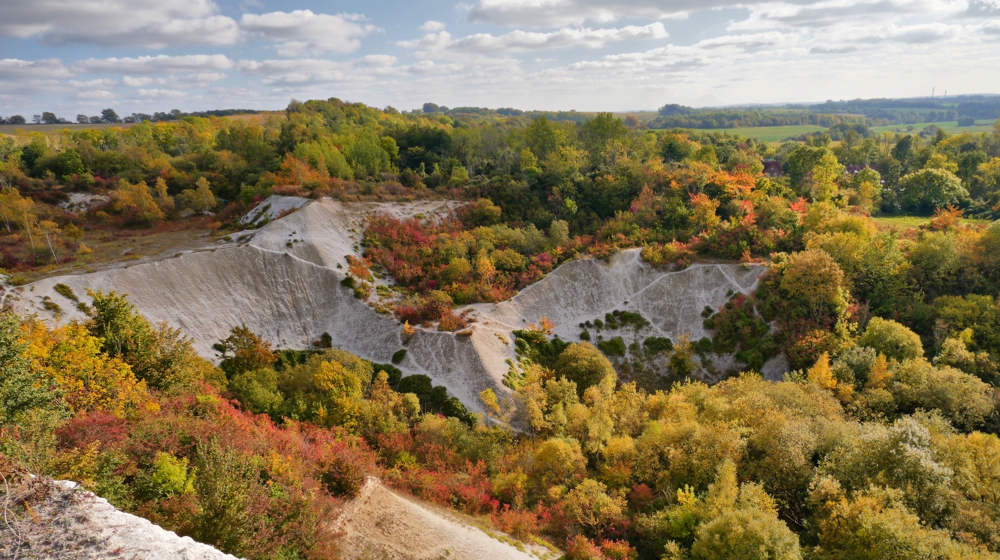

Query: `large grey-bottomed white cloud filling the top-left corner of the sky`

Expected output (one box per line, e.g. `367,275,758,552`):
0,0,239,48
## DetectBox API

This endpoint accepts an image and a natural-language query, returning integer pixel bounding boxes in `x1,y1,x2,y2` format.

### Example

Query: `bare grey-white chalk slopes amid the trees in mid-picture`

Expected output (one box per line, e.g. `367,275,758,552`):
15,197,780,410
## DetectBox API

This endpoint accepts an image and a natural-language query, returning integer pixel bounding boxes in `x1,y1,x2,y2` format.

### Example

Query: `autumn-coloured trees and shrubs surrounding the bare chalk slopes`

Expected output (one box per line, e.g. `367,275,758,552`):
0,99,1000,559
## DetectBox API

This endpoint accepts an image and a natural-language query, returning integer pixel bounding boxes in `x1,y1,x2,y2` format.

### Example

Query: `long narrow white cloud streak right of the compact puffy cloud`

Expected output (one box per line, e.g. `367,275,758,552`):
398,22,668,53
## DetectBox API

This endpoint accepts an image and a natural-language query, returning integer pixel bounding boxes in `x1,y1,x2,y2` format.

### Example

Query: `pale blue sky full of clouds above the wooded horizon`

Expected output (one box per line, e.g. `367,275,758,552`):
0,0,1000,116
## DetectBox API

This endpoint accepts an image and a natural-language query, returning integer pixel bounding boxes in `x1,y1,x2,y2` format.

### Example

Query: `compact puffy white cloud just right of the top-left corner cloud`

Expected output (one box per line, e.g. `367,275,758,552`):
240,10,375,57
